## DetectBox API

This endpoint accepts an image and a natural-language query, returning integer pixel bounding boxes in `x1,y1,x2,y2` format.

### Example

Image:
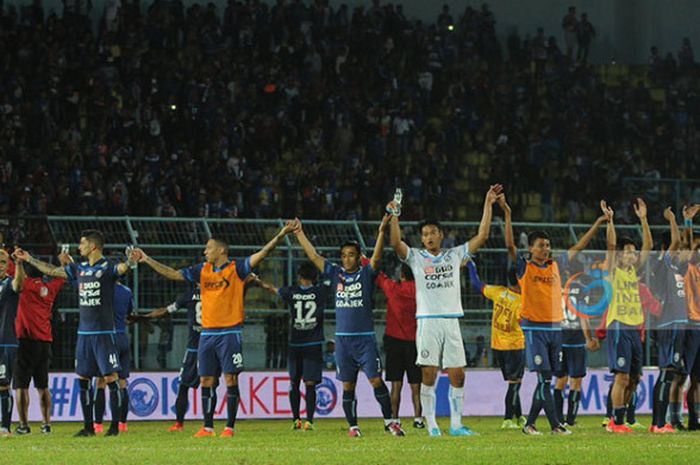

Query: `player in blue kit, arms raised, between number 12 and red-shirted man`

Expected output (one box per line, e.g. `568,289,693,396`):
295,215,405,437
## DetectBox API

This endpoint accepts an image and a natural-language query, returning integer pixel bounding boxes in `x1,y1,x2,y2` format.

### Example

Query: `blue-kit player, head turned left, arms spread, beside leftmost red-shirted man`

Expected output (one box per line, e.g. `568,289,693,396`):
14,229,135,437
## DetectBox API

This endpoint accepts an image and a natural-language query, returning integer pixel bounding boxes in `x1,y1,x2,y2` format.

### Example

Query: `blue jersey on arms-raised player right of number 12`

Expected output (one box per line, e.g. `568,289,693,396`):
323,260,377,336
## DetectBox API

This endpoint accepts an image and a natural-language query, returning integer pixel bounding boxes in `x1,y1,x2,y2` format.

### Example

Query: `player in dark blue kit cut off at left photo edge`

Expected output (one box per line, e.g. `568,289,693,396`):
0,249,21,436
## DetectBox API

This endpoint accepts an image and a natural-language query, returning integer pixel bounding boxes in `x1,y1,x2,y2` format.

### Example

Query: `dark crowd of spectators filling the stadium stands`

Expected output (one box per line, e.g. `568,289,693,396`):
0,0,700,225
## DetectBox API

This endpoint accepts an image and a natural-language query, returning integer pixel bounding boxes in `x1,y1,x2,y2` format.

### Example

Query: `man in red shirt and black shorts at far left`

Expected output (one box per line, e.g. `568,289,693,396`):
13,256,65,435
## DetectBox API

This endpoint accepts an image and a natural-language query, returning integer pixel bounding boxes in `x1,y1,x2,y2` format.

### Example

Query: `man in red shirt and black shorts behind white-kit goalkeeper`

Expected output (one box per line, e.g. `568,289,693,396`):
376,265,425,429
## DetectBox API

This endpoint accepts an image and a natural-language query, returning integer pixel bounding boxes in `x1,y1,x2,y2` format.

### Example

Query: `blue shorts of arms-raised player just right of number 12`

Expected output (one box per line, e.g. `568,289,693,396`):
335,335,382,383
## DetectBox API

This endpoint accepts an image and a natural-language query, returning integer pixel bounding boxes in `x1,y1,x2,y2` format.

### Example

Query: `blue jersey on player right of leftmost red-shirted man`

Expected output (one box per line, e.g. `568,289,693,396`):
64,257,119,335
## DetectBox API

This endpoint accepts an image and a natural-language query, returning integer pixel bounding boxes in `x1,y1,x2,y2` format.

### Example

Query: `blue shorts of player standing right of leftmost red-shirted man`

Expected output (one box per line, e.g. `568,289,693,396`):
75,332,121,378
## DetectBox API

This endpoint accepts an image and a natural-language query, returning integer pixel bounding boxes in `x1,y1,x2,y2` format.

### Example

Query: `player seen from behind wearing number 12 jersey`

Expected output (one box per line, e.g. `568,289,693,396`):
258,262,330,431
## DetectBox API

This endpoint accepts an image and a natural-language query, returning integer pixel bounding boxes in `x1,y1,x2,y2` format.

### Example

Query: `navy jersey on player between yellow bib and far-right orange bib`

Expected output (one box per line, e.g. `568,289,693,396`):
651,252,688,329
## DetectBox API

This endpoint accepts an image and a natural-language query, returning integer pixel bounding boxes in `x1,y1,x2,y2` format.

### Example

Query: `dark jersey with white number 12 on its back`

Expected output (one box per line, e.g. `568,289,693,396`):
278,284,330,347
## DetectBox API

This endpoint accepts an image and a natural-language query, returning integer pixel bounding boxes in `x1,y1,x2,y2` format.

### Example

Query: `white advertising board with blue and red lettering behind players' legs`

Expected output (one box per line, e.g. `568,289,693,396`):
15,368,658,421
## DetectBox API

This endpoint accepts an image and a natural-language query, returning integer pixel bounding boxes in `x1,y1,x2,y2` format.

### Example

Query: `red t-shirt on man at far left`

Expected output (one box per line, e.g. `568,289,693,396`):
15,278,66,342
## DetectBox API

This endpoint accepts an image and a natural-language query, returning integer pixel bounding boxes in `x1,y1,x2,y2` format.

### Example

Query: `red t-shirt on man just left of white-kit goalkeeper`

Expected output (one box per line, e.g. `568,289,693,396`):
376,272,417,341
